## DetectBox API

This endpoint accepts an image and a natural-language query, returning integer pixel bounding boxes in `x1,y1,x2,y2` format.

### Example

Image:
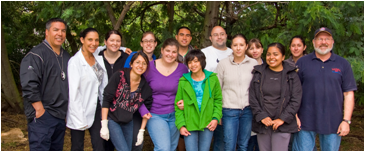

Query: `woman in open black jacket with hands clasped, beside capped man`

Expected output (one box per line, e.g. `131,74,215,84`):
249,43,302,151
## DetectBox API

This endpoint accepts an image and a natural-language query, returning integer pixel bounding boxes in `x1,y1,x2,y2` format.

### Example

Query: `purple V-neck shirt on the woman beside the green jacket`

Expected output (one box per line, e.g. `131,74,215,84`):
142,61,189,114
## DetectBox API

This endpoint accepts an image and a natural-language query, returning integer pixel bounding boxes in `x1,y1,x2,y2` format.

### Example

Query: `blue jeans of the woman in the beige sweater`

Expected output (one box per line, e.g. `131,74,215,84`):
222,106,252,151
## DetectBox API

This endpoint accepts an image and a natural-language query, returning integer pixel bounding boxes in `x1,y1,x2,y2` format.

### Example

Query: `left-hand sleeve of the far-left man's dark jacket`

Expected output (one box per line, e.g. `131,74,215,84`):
20,50,43,103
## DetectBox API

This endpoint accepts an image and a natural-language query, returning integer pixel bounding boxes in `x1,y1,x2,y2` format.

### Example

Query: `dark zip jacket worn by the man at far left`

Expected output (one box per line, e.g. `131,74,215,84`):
20,41,71,123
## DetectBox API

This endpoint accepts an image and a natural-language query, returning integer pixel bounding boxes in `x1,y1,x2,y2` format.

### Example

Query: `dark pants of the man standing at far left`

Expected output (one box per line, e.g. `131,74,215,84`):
28,110,66,151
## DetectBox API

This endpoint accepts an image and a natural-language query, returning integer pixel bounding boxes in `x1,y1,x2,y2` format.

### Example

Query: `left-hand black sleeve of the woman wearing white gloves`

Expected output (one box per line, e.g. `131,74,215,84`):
102,71,123,108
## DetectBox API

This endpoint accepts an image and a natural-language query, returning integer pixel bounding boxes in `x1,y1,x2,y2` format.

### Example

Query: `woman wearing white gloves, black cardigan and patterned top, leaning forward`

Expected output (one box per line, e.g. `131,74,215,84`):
100,51,152,151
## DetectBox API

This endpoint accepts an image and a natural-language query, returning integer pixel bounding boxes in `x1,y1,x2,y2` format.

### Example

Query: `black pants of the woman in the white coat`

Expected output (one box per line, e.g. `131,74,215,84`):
71,102,105,151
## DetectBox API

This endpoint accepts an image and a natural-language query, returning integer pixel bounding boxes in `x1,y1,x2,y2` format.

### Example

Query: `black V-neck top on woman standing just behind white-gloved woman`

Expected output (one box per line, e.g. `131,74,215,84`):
99,49,128,80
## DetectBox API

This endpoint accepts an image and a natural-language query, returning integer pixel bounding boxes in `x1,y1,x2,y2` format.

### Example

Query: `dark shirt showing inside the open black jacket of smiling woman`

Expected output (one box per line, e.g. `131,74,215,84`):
262,68,282,119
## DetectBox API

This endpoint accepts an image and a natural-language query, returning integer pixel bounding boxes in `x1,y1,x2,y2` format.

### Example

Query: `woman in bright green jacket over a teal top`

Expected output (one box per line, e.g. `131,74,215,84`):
175,50,222,151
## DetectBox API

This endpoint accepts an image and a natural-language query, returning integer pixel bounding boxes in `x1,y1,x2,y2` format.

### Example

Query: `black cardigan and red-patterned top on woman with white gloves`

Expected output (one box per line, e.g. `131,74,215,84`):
102,68,153,123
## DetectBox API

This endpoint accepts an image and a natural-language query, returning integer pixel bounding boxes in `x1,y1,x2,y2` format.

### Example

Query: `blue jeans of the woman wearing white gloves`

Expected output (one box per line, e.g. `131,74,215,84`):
108,119,133,151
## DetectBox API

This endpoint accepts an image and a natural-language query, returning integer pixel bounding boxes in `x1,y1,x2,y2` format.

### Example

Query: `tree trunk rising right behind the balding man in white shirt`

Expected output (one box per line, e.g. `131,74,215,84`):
200,1,220,48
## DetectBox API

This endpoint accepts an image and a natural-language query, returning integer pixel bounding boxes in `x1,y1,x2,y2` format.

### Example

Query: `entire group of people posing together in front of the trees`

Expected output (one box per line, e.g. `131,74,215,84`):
20,18,357,151
